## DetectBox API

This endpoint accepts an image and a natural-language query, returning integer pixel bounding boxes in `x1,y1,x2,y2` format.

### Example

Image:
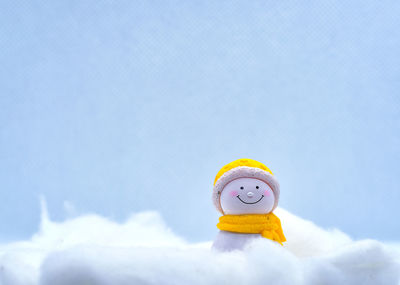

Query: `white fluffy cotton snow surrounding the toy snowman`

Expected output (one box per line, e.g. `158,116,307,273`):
0,201,400,285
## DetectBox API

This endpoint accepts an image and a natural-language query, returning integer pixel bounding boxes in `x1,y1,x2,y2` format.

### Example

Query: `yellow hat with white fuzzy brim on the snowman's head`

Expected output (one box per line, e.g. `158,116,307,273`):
213,158,280,213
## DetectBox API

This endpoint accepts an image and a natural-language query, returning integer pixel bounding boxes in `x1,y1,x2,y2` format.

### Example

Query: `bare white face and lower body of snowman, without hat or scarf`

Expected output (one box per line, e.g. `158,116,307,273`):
212,177,275,251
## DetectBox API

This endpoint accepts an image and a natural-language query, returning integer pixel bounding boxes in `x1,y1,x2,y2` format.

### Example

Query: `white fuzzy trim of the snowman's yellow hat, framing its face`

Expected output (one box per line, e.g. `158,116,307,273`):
212,166,280,214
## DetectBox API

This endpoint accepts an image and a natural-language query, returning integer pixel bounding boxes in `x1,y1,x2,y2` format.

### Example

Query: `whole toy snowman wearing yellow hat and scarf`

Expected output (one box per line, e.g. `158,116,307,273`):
212,159,286,251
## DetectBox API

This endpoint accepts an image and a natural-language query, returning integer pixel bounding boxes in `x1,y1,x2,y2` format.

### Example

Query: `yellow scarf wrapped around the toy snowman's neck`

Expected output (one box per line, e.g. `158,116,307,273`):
217,213,286,245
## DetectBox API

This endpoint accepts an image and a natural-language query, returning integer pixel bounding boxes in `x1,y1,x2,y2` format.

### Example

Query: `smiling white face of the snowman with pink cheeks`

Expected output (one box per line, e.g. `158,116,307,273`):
220,178,275,215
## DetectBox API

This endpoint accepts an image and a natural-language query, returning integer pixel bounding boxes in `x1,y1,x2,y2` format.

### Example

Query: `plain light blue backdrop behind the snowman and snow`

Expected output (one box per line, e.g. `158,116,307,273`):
0,0,400,241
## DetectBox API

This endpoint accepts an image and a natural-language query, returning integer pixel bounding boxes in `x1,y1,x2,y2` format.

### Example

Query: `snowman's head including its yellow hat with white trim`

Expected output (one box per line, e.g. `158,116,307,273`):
213,159,279,215
